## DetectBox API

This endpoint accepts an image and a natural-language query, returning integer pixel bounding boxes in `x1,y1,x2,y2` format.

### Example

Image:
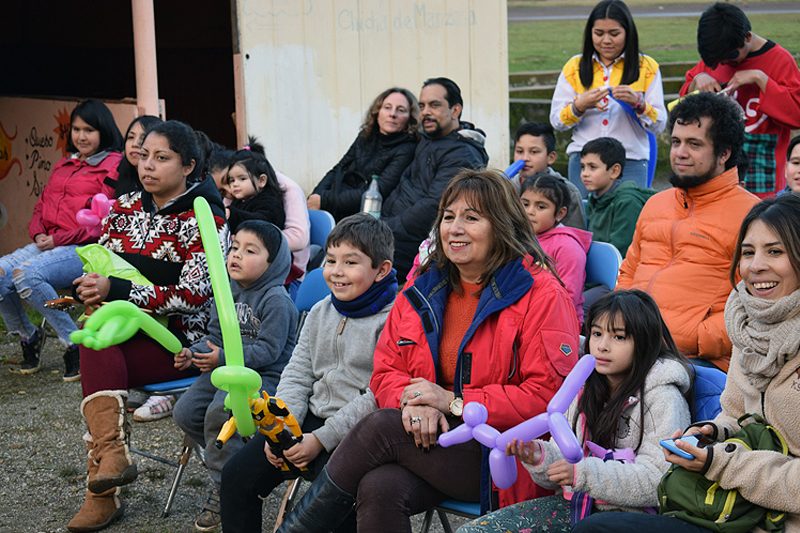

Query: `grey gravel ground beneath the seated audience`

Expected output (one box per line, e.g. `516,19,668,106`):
0,335,464,533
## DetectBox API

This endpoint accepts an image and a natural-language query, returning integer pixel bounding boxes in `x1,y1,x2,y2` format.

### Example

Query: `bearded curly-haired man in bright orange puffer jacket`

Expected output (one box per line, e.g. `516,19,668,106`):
617,93,758,371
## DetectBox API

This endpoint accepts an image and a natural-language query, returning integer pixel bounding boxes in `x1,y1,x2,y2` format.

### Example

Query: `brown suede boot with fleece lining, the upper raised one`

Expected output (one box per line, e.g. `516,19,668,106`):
81,391,139,495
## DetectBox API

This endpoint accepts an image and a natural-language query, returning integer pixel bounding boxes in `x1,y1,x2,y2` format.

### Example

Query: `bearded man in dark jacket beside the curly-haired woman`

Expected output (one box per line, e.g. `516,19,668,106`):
381,78,489,280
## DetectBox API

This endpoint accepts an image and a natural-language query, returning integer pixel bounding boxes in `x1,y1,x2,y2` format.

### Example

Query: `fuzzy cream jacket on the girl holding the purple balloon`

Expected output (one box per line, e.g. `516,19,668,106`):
523,358,690,511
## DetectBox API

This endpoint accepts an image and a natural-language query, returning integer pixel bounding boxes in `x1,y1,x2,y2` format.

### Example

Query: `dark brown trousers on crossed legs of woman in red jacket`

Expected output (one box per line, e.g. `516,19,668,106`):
324,409,481,533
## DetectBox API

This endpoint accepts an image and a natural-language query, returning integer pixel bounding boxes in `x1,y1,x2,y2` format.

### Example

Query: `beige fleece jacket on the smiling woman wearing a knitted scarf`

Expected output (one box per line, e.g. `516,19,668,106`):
705,283,800,532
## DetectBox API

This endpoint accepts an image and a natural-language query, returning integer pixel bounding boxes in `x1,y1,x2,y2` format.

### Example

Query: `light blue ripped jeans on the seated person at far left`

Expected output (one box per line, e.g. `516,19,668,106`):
0,243,83,345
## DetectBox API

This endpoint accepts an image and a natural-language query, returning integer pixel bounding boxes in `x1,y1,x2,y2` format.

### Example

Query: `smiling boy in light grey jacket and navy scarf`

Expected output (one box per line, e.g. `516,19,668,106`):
221,213,397,533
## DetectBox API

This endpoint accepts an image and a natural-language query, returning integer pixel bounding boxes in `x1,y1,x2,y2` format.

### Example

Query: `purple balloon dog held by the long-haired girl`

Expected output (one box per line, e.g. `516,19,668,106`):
438,354,596,489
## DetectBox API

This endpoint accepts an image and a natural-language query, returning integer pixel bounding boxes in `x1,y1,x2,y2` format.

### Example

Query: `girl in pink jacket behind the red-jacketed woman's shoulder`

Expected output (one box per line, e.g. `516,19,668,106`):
520,172,592,323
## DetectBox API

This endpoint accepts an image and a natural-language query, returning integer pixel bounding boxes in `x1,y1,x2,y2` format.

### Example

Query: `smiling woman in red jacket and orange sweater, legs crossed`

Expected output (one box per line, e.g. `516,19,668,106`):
280,170,578,532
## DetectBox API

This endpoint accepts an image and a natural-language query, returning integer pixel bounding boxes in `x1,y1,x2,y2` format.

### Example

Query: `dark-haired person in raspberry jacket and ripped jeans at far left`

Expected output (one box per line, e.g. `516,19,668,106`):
0,100,122,381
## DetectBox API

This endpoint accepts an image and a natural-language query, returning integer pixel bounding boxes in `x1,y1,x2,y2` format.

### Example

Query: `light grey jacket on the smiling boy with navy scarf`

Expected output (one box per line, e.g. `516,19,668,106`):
276,296,392,452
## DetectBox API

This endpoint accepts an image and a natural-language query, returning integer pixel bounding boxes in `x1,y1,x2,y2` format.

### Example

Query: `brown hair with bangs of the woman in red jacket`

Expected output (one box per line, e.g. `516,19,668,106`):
420,169,556,291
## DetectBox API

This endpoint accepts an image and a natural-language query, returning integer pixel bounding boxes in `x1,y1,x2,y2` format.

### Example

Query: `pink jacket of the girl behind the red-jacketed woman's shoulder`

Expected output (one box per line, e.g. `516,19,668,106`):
536,224,592,323
